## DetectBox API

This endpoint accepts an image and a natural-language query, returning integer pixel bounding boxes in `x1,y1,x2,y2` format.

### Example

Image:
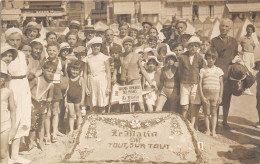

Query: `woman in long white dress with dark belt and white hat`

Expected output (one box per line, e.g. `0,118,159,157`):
5,28,31,164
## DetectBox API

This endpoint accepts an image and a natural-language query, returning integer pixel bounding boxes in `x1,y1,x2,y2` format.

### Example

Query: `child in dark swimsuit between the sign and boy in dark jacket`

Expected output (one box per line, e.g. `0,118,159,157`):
156,54,180,113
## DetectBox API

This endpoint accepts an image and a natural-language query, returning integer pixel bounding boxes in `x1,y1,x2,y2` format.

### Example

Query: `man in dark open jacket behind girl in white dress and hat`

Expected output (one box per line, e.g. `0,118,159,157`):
101,29,122,56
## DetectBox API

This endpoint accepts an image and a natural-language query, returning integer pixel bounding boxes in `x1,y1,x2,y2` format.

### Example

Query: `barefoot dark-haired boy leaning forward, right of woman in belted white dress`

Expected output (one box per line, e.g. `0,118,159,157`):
29,61,56,150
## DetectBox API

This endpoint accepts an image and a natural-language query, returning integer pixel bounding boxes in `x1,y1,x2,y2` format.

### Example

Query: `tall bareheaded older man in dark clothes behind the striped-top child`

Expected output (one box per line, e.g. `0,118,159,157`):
211,18,238,130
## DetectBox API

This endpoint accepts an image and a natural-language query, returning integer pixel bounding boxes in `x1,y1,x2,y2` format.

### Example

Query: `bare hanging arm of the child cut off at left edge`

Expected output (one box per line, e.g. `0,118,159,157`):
8,90,16,140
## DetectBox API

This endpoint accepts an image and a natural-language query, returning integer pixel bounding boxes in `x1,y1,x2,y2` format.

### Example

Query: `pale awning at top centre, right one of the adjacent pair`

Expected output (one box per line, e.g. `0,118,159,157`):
141,1,161,14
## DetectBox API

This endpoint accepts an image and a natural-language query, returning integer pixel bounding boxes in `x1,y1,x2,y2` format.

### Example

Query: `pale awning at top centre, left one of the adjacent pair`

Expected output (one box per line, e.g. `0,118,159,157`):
114,2,135,14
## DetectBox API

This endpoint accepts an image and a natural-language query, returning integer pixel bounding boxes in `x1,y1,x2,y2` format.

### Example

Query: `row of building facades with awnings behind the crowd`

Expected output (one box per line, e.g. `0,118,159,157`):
1,0,260,26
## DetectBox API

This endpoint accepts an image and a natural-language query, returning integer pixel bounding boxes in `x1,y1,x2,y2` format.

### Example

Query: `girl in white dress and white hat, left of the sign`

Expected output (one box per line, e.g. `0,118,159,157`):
84,37,111,113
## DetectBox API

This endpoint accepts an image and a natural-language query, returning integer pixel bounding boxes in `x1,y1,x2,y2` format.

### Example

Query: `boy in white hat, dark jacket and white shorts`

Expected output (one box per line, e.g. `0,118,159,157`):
178,36,206,126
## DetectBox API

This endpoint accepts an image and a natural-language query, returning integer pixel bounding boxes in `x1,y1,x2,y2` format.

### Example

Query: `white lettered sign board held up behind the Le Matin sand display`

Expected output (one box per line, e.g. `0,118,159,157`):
118,84,142,104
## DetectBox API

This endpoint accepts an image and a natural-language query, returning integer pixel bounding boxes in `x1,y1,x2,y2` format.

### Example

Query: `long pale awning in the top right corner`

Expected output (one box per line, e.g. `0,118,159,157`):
226,3,260,13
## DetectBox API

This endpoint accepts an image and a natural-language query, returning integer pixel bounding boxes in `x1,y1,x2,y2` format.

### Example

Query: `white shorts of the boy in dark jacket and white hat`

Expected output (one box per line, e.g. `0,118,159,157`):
180,83,201,105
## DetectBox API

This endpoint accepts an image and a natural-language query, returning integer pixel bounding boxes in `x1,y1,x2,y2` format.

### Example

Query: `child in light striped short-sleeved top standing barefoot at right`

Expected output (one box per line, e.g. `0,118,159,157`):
199,48,224,136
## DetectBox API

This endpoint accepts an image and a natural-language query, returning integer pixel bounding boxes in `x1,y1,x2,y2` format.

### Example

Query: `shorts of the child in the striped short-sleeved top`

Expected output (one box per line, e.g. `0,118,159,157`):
202,88,220,106
